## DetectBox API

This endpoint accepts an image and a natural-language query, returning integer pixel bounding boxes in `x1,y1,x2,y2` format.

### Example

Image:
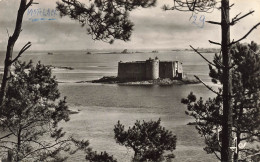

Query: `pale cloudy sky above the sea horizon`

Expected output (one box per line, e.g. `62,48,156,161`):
0,0,260,51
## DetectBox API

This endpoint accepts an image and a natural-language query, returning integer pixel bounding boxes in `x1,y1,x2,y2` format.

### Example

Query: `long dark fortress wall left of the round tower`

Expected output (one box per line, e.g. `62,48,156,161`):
118,62,146,80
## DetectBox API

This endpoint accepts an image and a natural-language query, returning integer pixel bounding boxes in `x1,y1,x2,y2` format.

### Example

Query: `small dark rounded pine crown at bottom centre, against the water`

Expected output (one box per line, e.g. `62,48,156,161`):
114,119,177,161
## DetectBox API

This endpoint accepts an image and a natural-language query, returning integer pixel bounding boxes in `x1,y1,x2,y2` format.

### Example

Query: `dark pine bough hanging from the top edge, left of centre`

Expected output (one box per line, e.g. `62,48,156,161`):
57,0,156,43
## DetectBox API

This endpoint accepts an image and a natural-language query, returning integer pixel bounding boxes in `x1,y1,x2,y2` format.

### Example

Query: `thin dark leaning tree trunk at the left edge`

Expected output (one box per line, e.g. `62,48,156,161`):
0,0,29,109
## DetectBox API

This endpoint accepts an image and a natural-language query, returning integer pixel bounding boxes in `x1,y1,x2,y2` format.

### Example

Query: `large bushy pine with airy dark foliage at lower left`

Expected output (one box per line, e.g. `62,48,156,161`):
0,61,89,162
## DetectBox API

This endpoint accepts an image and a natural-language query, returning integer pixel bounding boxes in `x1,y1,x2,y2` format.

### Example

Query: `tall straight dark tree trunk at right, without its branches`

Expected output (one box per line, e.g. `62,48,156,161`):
221,0,233,162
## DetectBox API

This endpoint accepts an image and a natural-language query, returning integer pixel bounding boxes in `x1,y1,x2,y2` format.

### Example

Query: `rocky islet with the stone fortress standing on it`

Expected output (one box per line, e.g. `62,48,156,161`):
92,57,199,85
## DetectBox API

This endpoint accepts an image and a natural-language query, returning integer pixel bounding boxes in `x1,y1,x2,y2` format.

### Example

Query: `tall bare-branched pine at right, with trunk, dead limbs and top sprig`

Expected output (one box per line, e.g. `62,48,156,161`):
163,0,260,162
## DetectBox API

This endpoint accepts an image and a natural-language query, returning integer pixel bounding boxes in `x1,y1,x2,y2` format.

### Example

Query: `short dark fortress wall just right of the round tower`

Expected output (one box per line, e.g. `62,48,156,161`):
159,61,175,78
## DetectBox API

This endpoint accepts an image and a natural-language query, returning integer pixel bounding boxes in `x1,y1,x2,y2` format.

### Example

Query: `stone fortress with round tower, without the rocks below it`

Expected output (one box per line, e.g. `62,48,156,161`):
118,57,183,81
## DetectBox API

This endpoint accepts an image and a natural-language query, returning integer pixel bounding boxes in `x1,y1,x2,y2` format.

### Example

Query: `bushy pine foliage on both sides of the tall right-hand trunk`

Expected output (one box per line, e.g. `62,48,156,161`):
182,42,260,161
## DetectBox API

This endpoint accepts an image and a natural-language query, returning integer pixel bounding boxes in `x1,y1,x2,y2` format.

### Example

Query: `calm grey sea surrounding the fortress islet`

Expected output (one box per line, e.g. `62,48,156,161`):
0,50,219,162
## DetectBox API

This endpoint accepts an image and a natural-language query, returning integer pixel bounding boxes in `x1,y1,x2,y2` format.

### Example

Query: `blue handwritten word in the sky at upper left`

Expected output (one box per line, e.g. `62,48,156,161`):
27,8,57,22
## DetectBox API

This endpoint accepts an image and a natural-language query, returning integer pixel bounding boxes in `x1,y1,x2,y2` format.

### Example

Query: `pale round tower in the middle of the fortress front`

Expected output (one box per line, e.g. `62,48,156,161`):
146,59,159,80
